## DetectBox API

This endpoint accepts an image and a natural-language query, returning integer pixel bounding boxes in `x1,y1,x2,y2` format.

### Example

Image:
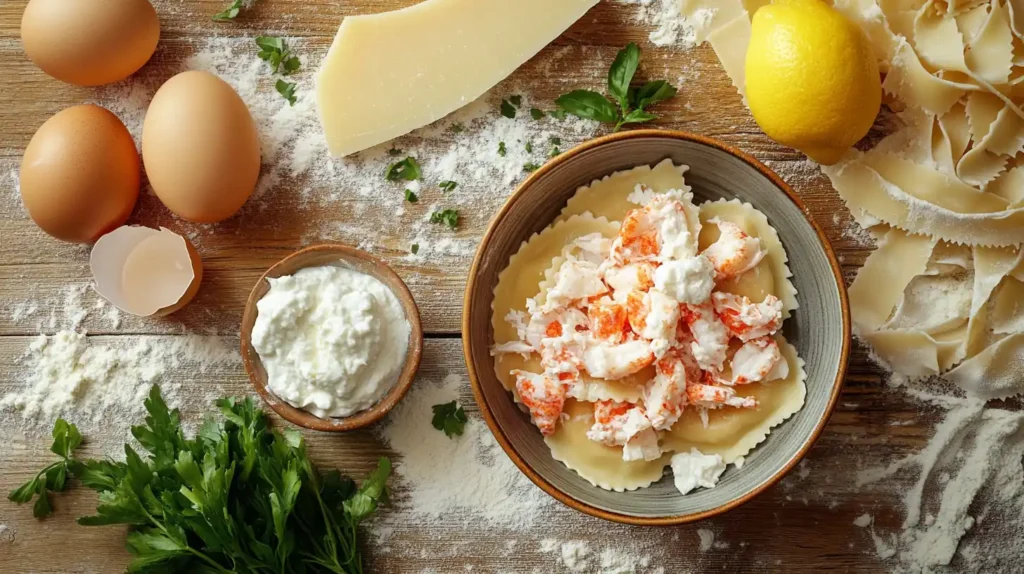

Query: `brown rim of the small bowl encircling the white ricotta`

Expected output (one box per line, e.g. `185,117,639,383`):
240,244,423,432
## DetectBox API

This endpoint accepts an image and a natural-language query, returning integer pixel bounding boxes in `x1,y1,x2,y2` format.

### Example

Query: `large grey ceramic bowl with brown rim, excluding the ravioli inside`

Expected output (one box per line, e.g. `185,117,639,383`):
463,130,850,525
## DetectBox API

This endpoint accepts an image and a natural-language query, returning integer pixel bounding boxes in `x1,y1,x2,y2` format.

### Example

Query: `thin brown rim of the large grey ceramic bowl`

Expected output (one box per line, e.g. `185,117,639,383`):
462,129,851,526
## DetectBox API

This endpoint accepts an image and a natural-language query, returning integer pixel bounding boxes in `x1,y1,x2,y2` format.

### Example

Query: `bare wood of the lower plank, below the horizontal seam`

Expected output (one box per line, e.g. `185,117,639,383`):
0,337,921,572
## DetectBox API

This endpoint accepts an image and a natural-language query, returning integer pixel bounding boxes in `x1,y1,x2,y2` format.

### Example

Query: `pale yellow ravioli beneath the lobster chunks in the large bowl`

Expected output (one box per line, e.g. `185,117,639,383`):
492,160,806,491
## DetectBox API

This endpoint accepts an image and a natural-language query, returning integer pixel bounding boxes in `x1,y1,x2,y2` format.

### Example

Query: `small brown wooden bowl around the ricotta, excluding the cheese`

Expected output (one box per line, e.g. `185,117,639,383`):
242,245,423,432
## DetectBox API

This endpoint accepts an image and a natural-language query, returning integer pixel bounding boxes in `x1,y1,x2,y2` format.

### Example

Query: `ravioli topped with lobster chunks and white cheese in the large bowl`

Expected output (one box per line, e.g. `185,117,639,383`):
492,161,806,491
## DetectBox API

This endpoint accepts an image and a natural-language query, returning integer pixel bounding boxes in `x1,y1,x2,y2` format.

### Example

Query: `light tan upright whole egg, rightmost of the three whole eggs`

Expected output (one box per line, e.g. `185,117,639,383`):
142,72,260,223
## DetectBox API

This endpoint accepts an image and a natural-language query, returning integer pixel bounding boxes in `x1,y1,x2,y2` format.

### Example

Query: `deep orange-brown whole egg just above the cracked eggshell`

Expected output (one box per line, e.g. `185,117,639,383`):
20,105,141,244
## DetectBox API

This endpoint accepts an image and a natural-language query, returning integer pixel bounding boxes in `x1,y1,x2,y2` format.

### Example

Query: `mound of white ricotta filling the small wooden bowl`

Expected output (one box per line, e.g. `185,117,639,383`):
252,266,411,416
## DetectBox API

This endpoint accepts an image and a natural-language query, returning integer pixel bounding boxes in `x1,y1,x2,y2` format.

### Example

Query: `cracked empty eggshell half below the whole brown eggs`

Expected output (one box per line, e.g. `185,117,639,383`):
89,225,203,317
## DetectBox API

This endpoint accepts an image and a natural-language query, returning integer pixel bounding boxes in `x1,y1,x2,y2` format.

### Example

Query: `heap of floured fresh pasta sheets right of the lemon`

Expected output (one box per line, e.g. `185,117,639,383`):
684,0,1024,398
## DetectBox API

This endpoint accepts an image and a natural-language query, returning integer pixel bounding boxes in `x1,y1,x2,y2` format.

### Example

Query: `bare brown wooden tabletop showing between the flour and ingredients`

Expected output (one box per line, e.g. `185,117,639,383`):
0,0,962,573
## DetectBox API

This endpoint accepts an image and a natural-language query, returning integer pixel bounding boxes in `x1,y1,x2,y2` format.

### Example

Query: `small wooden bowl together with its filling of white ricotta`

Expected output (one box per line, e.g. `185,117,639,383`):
242,244,423,432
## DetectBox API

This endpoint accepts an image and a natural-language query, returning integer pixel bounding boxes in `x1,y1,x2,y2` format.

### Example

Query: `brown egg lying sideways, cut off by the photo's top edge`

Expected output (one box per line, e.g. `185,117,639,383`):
22,0,160,86
